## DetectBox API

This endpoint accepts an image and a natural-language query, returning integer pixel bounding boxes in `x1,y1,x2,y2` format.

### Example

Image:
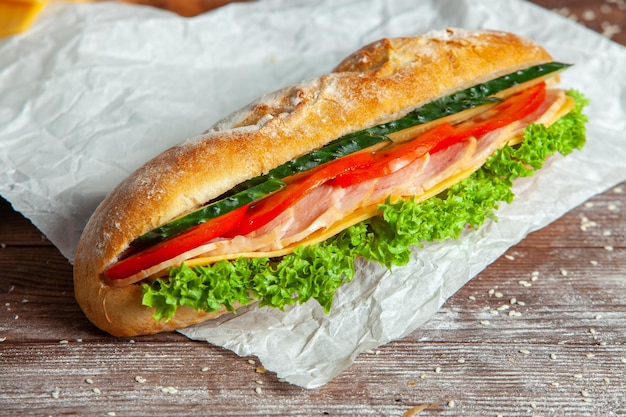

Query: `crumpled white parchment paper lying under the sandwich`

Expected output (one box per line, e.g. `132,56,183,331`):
0,0,626,388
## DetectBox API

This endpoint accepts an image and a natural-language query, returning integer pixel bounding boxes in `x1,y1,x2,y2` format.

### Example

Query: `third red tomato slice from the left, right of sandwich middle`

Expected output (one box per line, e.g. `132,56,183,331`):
333,123,454,188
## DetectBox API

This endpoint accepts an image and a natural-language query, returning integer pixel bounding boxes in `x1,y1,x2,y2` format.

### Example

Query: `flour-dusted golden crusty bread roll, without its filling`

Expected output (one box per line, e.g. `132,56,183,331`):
74,29,552,336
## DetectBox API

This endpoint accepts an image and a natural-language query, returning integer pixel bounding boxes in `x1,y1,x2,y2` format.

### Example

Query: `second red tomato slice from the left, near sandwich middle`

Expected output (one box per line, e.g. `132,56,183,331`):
226,152,374,237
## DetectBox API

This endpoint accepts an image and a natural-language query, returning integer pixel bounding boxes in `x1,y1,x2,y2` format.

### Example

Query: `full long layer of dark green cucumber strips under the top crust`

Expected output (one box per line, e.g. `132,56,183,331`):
131,62,570,246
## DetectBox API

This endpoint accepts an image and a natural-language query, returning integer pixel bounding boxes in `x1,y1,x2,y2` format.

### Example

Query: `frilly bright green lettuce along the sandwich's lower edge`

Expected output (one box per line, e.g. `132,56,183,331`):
142,91,588,320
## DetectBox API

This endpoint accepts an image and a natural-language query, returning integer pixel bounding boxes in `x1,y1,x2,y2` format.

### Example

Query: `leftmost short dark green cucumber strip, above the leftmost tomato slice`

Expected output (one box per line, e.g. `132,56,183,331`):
131,178,287,246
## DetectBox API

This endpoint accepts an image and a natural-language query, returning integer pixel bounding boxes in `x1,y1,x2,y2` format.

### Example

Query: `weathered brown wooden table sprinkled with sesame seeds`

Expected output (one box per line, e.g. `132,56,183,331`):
0,0,626,417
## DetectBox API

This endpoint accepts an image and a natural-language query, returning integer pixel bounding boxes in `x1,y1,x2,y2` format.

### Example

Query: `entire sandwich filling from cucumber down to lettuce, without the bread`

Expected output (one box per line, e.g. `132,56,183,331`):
97,63,585,319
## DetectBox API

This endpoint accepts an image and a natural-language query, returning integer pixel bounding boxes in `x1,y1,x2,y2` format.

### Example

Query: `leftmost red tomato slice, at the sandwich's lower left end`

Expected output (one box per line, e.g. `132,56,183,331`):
104,204,250,280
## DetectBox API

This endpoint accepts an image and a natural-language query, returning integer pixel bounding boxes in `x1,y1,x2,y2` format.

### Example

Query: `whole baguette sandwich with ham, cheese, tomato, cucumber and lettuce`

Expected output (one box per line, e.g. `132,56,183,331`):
74,29,586,336
